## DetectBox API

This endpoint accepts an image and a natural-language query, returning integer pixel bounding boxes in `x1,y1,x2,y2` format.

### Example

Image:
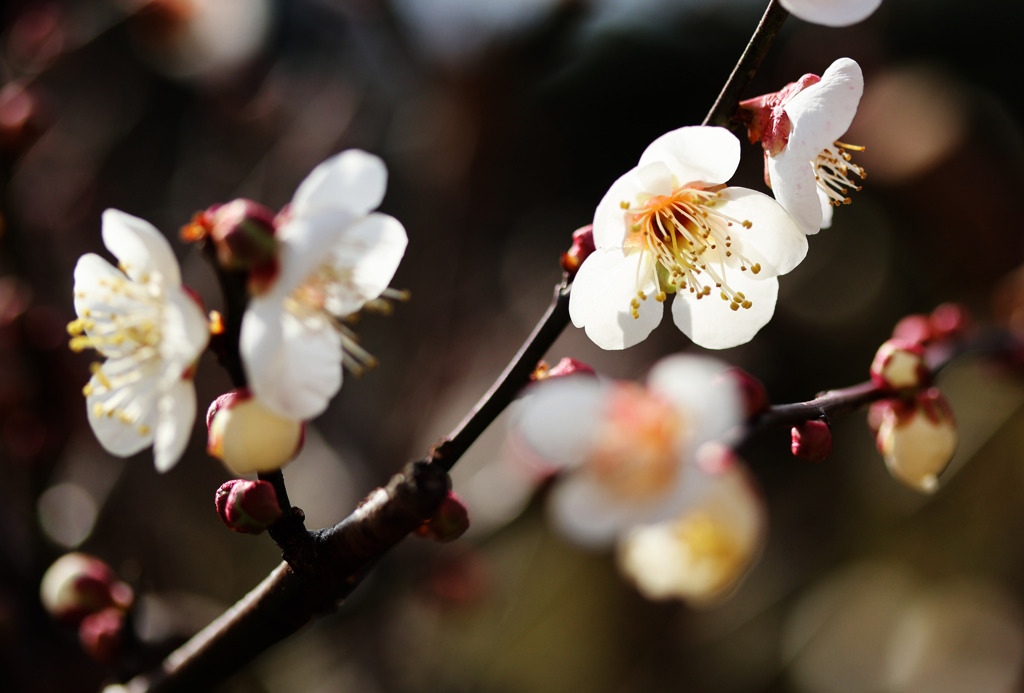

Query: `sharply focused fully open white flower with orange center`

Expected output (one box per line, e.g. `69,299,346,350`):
569,127,807,349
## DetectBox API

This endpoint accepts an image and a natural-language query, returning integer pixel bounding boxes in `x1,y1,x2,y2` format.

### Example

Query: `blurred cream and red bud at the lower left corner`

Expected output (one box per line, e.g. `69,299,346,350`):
39,553,134,624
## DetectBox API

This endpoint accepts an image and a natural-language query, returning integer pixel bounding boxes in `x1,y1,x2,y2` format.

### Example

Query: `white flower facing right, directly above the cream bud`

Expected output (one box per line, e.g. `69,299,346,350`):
240,149,407,420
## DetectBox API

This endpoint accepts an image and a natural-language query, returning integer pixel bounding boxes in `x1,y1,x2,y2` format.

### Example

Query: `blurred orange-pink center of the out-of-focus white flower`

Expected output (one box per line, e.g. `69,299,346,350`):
586,383,687,502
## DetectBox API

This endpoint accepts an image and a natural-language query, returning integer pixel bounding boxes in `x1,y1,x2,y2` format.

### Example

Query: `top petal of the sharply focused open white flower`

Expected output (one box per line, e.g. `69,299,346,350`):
639,125,739,185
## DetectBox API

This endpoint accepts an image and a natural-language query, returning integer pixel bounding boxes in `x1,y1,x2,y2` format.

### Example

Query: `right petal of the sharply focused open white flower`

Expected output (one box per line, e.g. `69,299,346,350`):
709,187,817,272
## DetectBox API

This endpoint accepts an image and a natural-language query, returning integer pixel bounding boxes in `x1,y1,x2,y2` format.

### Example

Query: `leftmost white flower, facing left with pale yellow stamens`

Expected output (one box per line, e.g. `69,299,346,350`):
68,210,210,472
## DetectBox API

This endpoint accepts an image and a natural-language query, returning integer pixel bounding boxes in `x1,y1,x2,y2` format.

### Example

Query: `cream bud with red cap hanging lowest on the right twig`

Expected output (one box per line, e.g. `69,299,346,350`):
876,388,956,493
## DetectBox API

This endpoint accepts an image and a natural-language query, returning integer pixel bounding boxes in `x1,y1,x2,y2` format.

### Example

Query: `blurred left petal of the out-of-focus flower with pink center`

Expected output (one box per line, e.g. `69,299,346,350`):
512,377,604,468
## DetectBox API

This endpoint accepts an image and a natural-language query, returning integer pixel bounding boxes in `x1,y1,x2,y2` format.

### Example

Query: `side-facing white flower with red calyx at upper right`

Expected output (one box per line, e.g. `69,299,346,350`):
740,59,865,233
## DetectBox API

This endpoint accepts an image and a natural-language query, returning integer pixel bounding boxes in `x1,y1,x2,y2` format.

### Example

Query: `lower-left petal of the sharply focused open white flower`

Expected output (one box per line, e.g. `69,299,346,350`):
569,249,664,349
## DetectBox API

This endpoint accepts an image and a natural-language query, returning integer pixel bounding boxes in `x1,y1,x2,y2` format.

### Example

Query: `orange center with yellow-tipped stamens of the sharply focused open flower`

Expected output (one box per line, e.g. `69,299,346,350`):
623,183,761,318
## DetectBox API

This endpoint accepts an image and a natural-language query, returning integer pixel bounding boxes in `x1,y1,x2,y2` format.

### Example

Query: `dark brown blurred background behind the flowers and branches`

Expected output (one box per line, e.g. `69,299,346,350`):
6,0,1024,693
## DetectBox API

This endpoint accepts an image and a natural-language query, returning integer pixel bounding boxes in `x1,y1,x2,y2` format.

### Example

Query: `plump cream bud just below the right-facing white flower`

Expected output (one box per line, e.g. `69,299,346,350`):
206,388,306,475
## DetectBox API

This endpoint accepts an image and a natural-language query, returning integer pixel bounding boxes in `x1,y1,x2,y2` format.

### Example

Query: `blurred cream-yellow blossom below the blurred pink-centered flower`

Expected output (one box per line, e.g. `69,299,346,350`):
618,443,767,606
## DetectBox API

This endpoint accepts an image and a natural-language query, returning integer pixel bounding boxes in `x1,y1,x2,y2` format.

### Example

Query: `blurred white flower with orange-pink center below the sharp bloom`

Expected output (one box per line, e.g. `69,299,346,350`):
511,356,742,546
